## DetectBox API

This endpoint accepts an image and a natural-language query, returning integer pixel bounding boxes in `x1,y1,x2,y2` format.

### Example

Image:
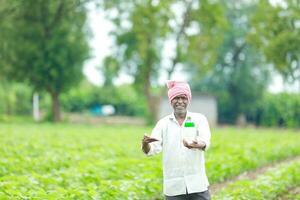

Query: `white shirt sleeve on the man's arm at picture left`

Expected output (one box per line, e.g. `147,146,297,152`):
146,121,163,156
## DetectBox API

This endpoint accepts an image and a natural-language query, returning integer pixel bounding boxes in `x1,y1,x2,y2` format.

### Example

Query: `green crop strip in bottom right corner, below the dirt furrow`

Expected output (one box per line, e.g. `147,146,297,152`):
213,161,300,200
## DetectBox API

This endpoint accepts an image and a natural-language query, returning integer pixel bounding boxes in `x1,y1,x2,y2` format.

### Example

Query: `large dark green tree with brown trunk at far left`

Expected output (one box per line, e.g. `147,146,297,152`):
1,0,88,121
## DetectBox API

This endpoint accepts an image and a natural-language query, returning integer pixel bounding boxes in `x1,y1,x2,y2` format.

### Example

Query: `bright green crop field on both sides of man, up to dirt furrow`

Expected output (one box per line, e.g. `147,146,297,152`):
0,123,300,199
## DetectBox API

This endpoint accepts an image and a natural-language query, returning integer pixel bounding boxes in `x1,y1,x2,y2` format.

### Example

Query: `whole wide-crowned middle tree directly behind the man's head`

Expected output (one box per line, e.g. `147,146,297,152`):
104,0,224,121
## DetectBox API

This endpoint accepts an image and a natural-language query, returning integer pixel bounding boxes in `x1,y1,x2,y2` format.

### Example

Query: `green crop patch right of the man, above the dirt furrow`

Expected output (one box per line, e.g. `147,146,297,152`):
206,128,299,183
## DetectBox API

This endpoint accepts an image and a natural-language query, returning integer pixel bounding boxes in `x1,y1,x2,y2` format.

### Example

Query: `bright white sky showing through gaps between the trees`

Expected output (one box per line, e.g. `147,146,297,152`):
83,3,300,93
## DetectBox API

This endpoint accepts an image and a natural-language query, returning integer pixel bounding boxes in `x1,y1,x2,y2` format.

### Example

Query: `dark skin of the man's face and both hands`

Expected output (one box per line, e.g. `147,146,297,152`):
142,95,206,153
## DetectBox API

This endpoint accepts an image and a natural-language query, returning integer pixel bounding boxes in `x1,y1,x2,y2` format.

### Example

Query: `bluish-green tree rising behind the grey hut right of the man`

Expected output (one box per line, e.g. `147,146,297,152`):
192,1,268,123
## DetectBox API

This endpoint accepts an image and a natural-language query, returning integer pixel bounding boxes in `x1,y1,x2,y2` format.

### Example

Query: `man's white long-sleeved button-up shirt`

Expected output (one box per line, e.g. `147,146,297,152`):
147,112,211,196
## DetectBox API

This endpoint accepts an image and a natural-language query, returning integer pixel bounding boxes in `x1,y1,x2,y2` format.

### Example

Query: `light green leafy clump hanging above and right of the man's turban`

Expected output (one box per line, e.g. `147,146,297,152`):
185,0,230,72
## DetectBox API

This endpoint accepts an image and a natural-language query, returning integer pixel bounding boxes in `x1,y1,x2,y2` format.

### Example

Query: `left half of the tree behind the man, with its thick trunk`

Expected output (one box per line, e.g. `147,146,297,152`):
103,0,173,121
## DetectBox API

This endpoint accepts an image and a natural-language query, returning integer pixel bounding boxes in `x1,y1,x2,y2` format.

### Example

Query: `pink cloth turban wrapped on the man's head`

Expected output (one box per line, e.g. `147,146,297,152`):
167,81,192,103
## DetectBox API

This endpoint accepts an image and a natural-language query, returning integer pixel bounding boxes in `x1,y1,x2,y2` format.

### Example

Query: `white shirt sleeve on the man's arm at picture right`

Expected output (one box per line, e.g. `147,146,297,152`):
197,116,211,151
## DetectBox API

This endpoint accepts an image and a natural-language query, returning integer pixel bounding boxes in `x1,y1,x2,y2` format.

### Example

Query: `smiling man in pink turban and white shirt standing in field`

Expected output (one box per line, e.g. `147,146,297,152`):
142,81,210,200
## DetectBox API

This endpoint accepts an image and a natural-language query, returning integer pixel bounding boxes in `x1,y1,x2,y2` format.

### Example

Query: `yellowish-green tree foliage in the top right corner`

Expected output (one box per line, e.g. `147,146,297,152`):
249,0,300,87
